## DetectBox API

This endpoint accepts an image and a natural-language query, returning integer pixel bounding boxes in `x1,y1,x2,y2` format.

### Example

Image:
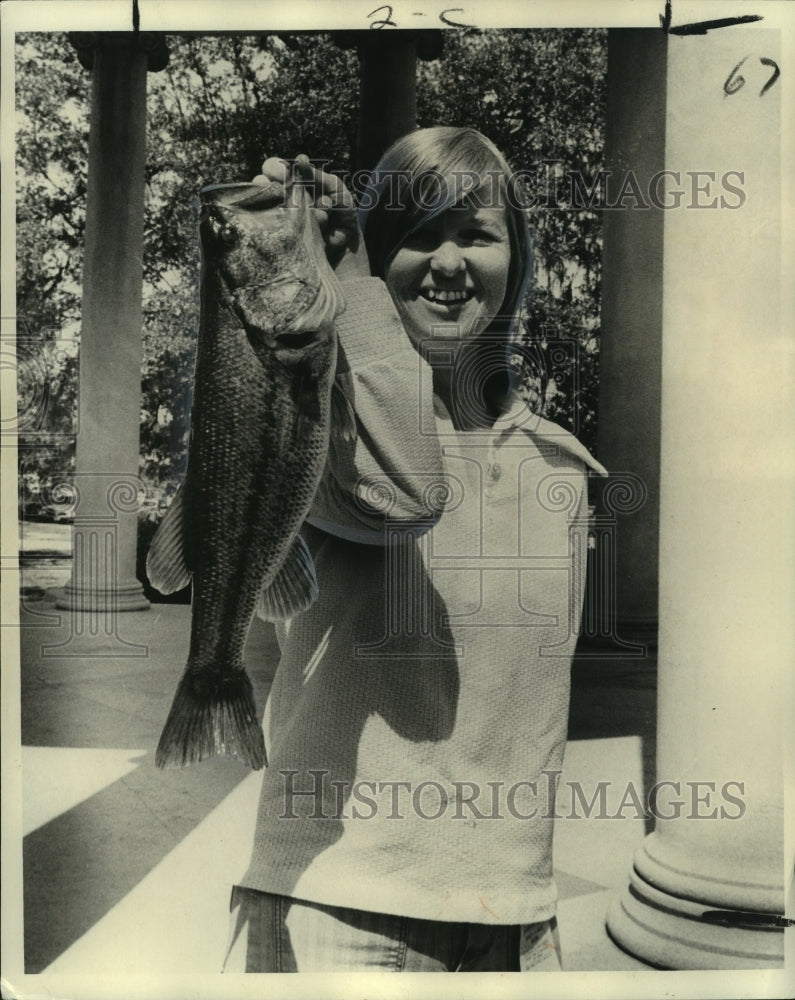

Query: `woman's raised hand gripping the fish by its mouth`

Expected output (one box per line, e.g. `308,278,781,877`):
253,153,370,279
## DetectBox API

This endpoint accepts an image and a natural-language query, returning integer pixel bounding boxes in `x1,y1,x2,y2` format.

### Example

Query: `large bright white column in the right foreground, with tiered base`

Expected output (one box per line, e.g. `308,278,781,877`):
608,28,793,969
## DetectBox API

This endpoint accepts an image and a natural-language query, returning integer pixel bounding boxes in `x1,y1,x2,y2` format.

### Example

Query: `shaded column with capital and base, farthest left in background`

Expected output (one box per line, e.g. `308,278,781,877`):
58,32,165,624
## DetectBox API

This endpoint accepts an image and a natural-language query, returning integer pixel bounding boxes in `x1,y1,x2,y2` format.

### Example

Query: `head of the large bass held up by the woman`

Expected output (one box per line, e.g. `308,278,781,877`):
200,184,344,364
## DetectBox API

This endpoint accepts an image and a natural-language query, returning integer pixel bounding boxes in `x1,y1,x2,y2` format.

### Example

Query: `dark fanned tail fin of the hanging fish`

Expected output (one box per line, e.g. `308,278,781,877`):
155,669,266,771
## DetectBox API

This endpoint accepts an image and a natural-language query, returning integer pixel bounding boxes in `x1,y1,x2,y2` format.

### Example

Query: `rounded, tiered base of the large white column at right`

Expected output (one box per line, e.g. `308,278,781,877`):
607,870,784,970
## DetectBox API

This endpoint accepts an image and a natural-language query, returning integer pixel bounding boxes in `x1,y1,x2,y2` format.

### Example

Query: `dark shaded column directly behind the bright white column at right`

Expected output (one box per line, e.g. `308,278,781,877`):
590,30,667,657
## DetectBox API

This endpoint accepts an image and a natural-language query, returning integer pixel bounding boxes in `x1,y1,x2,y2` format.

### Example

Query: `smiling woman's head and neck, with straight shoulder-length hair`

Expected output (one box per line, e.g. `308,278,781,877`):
359,126,531,428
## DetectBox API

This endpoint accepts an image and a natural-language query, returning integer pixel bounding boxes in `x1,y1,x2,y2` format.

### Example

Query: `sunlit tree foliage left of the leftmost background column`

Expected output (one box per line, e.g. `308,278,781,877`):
16,33,90,517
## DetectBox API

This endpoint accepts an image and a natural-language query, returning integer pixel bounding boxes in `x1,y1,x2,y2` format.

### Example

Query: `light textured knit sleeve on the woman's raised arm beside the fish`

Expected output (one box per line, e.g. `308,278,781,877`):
308,278,444,544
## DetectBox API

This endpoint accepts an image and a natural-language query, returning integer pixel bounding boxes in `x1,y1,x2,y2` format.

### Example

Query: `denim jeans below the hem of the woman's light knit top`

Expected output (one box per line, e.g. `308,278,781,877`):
224,886,560,972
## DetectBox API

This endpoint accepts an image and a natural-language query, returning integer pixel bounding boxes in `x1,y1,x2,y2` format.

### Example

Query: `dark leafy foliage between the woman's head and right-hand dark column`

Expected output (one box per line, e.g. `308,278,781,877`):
418,29,607,450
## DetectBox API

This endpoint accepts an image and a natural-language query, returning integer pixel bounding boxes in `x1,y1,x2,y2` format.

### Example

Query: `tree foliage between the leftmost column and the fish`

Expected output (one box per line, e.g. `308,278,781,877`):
141,36,357,508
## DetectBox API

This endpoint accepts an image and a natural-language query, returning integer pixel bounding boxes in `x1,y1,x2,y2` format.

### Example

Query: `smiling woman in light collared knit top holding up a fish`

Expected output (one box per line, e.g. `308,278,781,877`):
227,128,604,971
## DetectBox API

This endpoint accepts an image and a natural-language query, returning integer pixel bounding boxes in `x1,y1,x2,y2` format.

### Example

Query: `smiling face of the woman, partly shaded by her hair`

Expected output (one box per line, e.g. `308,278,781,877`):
385,200,511,356
